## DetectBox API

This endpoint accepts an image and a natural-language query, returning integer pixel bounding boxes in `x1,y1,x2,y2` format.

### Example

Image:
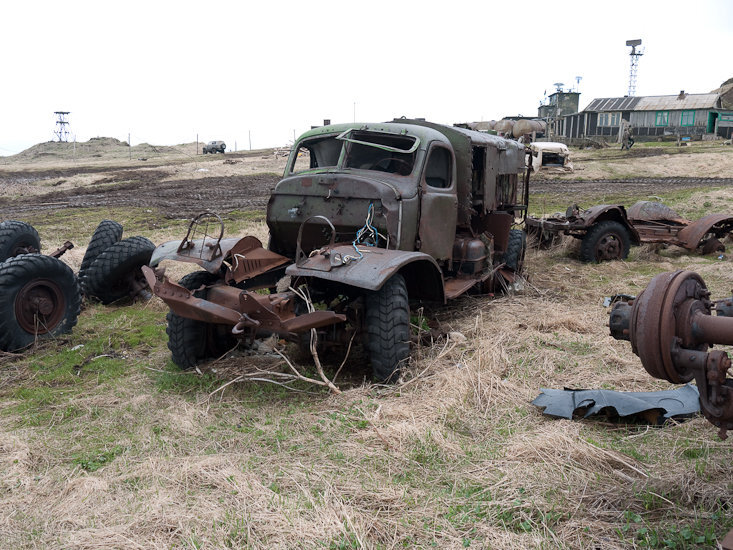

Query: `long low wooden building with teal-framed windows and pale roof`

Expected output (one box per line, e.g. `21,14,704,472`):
557,91,733,140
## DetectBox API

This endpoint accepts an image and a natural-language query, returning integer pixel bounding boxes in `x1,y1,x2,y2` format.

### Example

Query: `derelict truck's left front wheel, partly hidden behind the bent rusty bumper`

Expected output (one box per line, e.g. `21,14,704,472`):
166,271,237,369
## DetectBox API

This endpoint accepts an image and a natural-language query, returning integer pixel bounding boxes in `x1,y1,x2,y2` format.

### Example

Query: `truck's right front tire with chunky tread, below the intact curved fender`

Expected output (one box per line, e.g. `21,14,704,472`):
366,273,410,383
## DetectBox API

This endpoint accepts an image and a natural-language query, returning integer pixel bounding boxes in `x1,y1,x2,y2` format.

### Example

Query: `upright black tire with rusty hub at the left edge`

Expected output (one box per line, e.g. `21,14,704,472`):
0,254,81,351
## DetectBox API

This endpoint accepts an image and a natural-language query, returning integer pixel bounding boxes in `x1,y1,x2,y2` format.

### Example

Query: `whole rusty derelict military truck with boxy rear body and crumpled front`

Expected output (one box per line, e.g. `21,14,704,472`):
144,119,529,381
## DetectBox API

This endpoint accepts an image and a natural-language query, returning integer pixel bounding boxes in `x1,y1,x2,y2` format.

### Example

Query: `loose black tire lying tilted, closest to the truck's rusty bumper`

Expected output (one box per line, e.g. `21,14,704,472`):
84,237,155,304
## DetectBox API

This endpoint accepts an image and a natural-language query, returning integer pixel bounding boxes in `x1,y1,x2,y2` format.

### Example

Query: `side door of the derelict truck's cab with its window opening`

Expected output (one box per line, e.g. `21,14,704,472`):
419,143,458,260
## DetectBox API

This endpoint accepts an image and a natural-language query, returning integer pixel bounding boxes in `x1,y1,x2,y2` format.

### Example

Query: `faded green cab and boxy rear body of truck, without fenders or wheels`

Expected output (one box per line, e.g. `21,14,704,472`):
267,119,526,288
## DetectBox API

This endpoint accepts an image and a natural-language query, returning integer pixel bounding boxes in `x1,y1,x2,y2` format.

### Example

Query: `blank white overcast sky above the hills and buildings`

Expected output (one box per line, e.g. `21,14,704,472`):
0,0,733,155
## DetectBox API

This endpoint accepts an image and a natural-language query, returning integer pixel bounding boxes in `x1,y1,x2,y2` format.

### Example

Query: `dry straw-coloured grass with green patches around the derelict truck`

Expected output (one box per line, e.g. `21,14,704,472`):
0,143,733,549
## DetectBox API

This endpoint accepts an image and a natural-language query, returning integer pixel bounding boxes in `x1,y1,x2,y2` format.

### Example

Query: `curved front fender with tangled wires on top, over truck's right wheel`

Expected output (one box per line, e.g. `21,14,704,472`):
285,245,445,303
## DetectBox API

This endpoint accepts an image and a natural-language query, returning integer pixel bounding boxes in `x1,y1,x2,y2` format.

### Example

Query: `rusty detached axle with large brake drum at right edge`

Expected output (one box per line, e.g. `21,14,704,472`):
609,271,733,439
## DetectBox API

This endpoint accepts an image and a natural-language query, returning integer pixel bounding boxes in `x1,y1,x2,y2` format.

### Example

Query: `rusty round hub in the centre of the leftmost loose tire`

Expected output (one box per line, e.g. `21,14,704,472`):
15,279,66,334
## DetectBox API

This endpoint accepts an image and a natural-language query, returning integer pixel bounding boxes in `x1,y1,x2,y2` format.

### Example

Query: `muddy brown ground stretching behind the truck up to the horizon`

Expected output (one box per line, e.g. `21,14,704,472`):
0,140,733,222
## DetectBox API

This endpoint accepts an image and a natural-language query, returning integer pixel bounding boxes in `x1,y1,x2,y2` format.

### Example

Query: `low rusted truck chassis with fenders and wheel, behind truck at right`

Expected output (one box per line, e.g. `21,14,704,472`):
526,201,733,262
